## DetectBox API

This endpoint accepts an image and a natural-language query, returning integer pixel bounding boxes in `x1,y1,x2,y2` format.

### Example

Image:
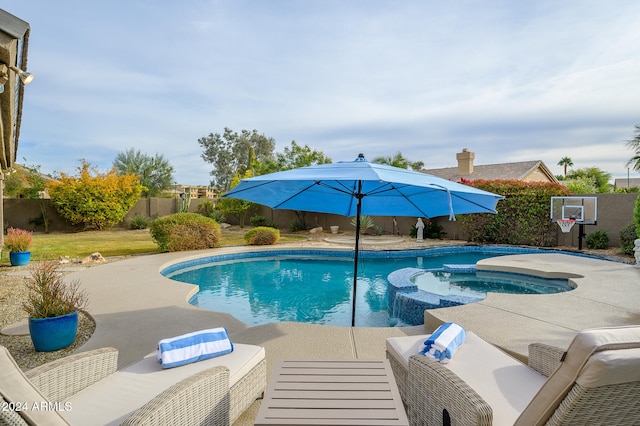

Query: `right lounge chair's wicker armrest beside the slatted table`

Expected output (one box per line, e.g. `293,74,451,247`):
407,355,493,425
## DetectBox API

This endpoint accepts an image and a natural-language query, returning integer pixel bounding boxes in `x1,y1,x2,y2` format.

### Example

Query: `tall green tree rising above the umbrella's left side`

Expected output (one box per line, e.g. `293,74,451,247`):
198,127,276,192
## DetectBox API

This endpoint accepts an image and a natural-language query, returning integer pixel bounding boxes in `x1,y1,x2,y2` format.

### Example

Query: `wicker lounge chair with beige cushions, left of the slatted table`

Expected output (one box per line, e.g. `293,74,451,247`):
0,344,266,425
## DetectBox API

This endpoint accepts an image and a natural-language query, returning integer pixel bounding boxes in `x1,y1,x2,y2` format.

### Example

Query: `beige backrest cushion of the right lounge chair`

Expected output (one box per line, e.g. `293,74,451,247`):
517,326,640,426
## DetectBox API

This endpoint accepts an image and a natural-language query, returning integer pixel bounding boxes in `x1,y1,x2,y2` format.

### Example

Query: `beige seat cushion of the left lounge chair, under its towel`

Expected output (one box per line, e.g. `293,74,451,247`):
62,343,265,425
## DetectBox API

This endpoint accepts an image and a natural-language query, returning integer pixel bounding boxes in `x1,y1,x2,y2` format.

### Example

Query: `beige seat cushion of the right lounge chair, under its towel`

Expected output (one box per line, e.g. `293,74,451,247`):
387,331,546,425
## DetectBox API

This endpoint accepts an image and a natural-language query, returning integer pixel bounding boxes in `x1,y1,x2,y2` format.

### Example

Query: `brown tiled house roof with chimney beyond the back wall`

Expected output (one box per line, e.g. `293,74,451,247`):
421,160,558,182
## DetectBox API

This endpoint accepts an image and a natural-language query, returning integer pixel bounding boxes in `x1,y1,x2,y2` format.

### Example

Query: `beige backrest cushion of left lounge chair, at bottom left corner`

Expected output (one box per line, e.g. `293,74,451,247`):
0,346,67,425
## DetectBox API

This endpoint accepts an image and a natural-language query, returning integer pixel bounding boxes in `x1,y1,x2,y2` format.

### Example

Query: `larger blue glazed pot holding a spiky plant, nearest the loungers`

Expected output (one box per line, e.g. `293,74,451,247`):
29,311,78,352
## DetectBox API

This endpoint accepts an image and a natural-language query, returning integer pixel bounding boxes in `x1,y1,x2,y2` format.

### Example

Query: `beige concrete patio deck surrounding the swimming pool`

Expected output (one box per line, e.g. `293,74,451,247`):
6,244,640,424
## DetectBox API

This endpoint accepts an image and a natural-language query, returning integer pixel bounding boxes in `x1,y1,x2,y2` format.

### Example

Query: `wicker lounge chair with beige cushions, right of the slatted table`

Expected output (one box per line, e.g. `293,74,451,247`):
387,326,640,425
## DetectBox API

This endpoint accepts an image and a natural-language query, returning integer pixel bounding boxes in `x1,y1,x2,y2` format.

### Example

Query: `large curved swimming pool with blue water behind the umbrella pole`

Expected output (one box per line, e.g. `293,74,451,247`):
162,246,566,327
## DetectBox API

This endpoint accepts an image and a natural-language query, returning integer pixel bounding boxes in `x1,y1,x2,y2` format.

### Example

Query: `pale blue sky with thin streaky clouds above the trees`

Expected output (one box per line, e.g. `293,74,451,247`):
0,0,640,185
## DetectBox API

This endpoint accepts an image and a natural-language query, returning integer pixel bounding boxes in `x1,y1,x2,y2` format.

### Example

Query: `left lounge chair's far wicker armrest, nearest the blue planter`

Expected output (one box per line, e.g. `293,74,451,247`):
25,348,118,402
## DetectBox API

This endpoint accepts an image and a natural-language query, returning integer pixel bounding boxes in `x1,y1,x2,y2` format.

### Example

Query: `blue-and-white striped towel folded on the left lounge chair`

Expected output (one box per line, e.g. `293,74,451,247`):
158,327,233,368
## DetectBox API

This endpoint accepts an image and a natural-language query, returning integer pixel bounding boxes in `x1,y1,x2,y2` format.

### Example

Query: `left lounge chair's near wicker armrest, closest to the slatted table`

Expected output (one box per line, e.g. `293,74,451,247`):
122,366,230,425
